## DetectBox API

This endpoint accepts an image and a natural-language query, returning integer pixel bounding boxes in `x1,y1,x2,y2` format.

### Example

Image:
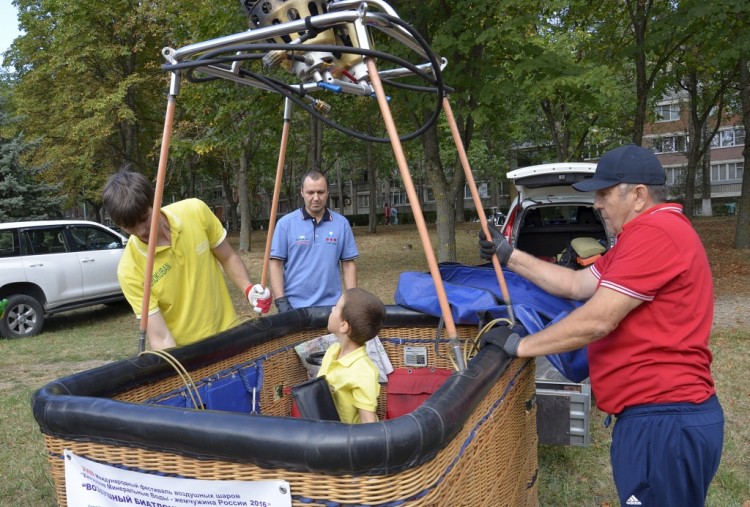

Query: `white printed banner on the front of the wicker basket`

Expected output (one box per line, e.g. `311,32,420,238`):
65,449,292,507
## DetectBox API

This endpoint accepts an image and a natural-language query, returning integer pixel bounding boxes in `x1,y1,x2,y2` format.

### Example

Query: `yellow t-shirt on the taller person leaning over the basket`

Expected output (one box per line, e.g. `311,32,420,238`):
117,199,237,346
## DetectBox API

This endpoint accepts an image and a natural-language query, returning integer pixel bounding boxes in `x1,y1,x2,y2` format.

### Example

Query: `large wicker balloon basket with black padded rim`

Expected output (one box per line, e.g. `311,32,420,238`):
34,307,537,507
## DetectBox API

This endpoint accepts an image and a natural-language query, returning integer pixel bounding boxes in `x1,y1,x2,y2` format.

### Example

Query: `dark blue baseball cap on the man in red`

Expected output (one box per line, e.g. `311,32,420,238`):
573,144,667,192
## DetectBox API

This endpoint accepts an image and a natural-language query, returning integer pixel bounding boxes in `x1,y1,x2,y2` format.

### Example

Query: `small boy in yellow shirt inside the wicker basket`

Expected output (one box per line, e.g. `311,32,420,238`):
318,288,385,424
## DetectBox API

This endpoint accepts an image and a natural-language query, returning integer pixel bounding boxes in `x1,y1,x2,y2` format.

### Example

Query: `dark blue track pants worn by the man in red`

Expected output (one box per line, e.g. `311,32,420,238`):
610,396,724,507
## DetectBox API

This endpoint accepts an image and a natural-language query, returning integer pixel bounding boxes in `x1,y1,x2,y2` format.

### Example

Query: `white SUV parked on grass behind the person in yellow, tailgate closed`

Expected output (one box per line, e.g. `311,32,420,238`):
0,220,127,338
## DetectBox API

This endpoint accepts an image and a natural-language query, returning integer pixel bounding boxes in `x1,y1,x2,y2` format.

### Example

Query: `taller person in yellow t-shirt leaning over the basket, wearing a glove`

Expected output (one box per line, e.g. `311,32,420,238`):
102,171,271,349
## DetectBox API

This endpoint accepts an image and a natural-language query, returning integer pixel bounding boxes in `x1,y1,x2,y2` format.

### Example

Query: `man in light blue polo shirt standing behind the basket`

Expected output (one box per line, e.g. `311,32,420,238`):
269,171,359,312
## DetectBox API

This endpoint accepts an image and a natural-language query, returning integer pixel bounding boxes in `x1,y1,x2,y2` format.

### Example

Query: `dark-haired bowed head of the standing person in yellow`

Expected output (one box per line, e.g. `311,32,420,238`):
102,170,154,227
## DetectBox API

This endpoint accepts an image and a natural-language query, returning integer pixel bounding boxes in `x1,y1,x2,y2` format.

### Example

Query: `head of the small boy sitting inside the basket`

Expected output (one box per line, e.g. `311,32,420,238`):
328,288,385,345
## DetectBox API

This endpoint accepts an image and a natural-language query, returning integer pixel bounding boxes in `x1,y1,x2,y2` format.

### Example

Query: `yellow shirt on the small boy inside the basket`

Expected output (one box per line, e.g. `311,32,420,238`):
318,343,380,424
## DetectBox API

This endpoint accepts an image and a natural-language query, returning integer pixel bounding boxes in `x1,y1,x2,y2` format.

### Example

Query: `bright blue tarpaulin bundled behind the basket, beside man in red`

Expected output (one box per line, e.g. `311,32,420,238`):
394,263,589,382
